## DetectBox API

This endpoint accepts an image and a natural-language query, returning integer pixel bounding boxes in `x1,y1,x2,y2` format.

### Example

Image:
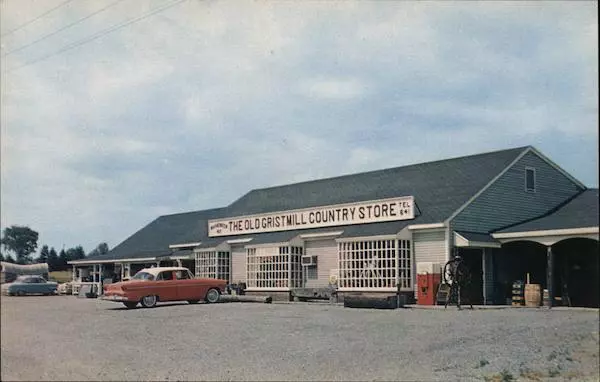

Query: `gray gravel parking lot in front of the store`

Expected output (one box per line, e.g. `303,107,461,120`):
0,296,599,381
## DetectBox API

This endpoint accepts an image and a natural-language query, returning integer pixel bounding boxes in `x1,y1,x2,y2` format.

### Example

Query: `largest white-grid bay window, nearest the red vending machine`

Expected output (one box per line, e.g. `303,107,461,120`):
338,239,412,290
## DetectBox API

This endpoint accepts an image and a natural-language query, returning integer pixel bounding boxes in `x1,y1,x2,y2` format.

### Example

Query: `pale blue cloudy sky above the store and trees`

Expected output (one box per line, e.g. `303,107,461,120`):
0,0,598,252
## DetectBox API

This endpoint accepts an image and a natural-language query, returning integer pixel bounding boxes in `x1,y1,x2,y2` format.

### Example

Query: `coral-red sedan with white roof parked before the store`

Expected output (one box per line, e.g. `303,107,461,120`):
102,267,227,309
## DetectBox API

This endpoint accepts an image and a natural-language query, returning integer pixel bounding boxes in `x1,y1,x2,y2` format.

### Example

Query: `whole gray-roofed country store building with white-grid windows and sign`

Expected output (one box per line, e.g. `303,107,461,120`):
71,146,598,306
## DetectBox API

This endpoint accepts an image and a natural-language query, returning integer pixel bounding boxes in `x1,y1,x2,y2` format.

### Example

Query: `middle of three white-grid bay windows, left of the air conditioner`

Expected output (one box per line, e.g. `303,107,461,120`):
246,246,302,289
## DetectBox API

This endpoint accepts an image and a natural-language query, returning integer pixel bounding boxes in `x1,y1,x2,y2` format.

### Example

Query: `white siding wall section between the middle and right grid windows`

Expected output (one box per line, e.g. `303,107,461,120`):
303,239,338,288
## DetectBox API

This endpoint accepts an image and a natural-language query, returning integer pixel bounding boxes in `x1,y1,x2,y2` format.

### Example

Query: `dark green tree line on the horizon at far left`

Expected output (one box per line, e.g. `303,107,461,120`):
0,225,109,271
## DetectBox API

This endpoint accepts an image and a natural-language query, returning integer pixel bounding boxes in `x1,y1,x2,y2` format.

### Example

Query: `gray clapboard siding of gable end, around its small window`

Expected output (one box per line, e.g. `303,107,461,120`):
452,152,582,233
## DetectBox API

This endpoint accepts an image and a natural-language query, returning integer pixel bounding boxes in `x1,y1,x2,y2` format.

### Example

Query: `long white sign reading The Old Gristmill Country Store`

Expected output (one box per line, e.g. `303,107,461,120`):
208,196,415,237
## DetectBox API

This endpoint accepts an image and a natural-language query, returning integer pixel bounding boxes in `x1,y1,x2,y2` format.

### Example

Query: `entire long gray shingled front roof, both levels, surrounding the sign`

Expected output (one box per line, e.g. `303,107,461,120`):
85,146,528,260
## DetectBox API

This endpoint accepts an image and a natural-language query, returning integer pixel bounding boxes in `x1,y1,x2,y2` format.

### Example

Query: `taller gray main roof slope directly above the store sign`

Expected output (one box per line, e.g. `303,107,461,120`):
226,146,528,223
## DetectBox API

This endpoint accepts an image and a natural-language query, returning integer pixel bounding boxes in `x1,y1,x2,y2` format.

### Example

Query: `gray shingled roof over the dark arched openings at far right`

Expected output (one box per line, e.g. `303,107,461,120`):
497,188,598,233
